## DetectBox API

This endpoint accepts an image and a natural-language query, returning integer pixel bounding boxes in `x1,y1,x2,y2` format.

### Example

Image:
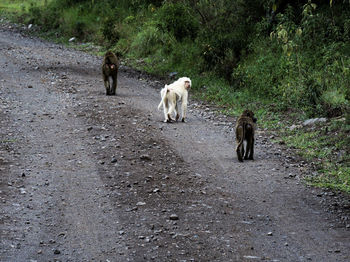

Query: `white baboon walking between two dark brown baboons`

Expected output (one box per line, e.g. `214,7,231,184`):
158,77,192,122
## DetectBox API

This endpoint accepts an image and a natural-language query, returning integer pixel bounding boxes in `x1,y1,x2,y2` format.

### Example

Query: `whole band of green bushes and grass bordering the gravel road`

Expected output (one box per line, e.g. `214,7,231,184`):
0,0,350,193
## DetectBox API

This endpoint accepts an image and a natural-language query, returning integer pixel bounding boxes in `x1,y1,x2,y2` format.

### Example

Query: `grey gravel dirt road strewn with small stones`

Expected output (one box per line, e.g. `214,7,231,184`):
0,23,350,262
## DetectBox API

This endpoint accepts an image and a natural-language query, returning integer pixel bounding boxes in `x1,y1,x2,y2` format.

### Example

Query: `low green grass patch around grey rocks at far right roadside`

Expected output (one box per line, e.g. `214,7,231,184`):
284,119,350,193
